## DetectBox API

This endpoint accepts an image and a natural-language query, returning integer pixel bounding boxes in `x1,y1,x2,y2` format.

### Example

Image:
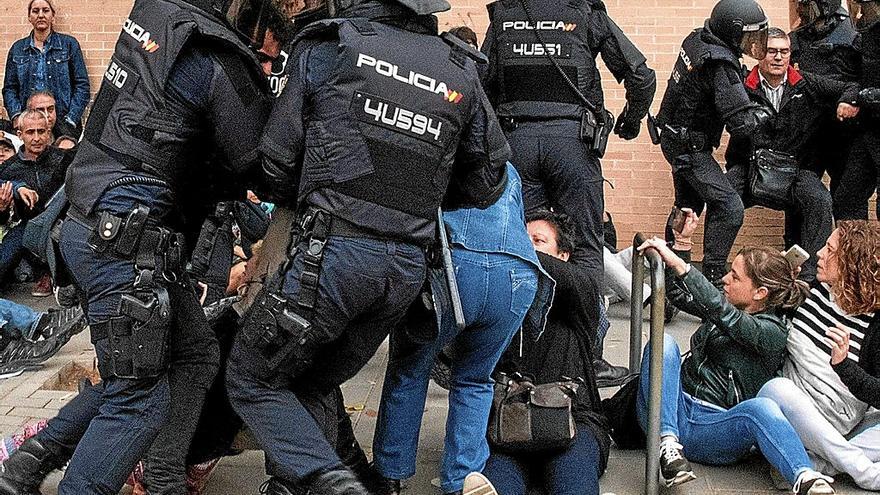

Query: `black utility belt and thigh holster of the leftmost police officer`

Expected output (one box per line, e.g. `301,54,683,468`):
71,205,185,379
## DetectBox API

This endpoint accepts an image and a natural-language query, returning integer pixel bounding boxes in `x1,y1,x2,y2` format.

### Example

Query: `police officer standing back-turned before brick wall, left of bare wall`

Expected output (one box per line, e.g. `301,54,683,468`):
482,0,656,281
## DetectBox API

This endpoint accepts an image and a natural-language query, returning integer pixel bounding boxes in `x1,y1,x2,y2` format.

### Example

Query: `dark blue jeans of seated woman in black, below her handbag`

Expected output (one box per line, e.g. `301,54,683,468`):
483,425,602,495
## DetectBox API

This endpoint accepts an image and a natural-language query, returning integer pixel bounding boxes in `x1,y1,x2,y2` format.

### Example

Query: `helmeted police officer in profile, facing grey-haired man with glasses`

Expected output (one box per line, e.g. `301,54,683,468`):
656,0,770,282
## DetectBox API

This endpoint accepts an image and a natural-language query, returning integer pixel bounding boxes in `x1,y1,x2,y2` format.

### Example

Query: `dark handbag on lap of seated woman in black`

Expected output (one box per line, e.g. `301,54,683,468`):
488,374,580,452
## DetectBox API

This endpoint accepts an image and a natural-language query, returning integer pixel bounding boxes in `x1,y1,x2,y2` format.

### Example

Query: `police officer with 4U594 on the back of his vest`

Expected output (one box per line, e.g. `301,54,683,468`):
227,0,509,495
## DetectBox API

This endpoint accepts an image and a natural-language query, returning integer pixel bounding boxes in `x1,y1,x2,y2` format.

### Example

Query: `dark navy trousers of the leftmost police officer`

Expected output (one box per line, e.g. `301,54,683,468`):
37,220,219,495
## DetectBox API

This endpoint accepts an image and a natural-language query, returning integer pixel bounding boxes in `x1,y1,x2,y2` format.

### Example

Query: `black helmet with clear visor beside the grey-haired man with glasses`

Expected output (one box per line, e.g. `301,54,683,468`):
709,0,770,60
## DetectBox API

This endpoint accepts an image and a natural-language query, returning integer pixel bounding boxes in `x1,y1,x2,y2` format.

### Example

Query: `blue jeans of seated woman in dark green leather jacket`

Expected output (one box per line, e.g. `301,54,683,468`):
636,335,813,484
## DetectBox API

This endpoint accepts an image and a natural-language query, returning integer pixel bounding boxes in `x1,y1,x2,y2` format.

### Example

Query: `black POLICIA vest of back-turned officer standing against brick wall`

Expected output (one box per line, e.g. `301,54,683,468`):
488,0,604,118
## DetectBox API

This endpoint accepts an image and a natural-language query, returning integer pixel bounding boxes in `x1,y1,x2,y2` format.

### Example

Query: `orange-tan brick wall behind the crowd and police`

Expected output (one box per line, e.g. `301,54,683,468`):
0,0,872,259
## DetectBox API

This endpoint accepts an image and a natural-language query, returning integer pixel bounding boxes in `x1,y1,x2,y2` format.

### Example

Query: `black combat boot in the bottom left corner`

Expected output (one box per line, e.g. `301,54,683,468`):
0,438,64,495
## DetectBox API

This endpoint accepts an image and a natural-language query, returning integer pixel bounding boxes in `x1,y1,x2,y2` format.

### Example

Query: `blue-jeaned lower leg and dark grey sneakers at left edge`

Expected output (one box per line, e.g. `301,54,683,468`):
0,299,86,378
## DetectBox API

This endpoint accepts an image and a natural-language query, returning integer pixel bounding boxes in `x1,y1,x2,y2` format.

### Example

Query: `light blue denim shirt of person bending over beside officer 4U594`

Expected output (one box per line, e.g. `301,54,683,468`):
432,162,556,338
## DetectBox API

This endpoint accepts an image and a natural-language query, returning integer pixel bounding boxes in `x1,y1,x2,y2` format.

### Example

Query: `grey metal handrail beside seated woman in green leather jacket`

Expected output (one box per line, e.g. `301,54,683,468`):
629,233,666,495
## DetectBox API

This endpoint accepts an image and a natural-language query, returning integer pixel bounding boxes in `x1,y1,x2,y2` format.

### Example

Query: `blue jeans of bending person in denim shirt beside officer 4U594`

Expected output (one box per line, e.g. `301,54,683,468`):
373,247,538,493
